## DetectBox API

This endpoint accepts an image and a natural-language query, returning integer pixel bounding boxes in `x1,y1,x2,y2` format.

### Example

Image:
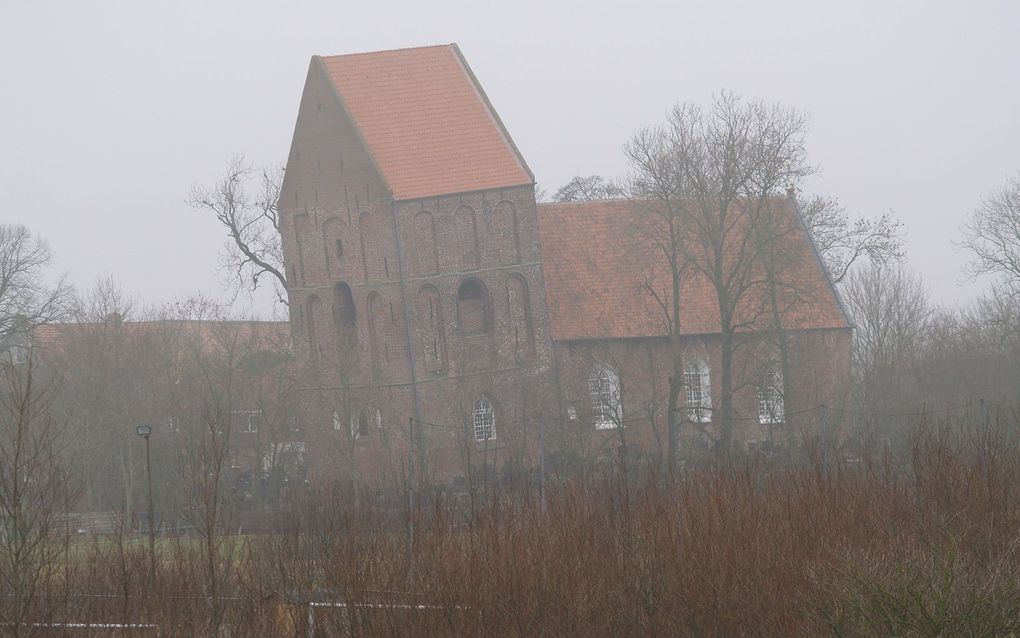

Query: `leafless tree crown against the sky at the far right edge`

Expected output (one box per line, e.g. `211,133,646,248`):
958,173,1020,290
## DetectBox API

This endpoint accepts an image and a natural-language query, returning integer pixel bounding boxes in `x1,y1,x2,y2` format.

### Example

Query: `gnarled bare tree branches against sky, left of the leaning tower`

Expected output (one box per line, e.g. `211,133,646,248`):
187,155,287,306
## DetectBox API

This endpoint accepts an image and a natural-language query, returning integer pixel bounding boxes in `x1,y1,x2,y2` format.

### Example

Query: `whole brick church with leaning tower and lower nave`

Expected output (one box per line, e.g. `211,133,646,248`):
278,44,851,484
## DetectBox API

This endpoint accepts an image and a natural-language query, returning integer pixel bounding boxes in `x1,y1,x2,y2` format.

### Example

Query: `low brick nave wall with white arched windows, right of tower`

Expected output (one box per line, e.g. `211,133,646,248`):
552,329,851,461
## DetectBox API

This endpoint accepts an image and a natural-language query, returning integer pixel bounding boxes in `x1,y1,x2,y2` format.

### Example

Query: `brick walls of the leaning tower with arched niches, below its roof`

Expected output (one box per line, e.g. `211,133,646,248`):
281,57,555,481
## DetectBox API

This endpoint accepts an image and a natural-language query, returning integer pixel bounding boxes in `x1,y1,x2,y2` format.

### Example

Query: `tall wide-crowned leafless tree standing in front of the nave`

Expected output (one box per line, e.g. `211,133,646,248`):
625,93,813,453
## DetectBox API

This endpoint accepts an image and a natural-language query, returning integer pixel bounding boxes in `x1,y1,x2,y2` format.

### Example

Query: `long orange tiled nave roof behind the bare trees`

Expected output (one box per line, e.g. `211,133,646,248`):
539,200,848,340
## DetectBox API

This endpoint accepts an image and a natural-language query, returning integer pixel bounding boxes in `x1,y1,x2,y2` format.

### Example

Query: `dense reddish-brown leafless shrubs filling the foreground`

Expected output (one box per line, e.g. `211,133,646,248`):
7,416,1020,636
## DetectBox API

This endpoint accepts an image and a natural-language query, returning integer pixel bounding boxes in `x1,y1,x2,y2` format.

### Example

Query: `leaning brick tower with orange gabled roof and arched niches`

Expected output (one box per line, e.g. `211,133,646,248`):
279,45,555,482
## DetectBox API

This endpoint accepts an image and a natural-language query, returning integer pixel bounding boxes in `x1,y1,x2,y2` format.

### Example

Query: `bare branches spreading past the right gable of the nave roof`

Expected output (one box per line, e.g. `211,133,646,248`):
798,195,904,284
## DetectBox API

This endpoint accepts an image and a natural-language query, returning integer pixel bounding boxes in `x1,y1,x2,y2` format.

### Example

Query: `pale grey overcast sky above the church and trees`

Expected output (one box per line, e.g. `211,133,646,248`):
0,0,1020,313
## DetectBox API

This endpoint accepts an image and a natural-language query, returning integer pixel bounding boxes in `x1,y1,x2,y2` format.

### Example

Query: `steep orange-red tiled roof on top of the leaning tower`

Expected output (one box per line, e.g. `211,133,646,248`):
320,44,534,200
